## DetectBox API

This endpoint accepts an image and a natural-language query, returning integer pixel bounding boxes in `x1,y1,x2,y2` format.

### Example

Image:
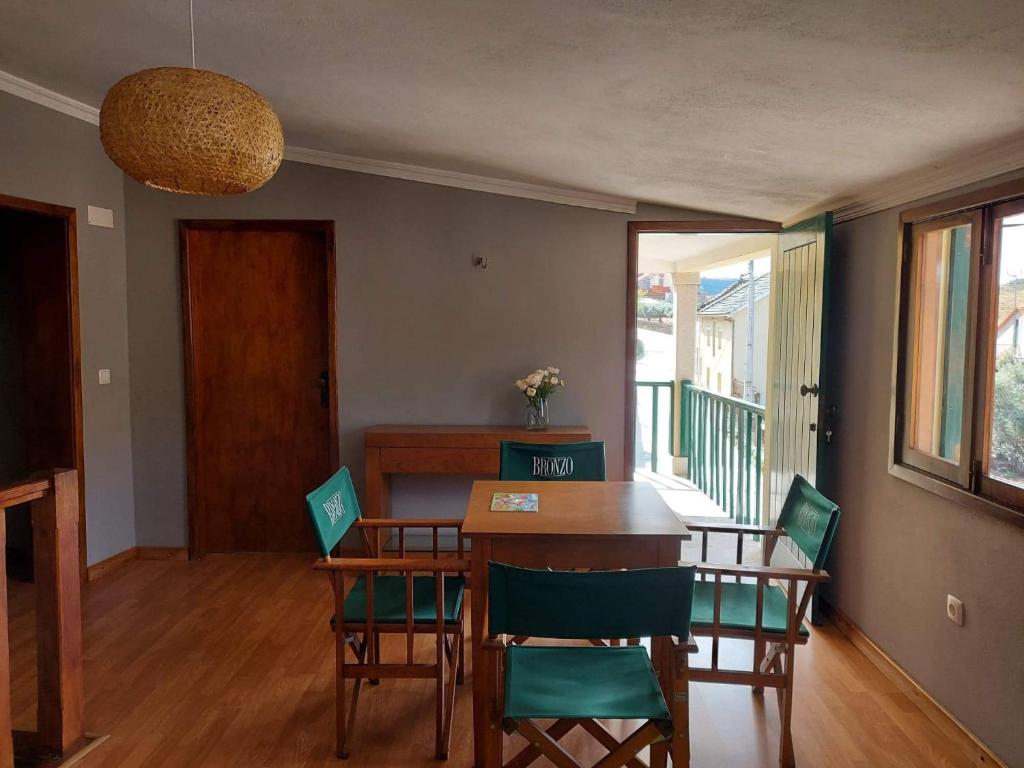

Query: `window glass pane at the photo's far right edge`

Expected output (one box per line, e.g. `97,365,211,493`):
988,213,1024,487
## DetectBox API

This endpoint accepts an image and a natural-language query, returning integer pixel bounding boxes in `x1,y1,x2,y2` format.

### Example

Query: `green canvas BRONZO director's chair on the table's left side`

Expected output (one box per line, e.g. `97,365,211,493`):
306,467,469,759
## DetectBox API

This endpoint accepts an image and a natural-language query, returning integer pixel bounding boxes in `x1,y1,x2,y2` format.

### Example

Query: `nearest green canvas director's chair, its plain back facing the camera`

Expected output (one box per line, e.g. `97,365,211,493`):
485,562,696,768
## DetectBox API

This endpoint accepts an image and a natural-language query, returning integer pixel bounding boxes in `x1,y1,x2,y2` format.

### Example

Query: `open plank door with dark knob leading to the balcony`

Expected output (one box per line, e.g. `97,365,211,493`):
765,213,831,566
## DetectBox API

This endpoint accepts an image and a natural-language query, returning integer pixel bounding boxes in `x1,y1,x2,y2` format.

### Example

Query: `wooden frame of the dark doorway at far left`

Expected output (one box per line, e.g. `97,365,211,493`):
0,194,88,585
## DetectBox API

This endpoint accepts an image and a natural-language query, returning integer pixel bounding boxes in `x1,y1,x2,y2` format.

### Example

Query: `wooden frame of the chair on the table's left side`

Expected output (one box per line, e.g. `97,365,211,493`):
313,518,470,760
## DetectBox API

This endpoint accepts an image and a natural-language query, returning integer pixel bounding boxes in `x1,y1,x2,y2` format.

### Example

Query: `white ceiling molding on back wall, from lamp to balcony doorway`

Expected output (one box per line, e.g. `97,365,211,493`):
285,146,637,214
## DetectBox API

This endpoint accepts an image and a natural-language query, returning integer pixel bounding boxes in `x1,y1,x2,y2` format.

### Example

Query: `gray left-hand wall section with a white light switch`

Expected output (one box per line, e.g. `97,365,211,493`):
0,93,135,563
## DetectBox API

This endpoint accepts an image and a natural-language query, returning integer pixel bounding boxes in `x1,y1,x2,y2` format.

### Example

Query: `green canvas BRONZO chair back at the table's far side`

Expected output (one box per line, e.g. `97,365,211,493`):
498,440,605,480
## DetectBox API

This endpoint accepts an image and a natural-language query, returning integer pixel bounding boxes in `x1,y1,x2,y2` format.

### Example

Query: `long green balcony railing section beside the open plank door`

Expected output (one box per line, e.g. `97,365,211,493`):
680,381,765,524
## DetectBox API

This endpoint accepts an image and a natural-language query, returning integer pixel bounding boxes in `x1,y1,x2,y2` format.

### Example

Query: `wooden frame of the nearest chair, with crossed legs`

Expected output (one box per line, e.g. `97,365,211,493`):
482,635,697,768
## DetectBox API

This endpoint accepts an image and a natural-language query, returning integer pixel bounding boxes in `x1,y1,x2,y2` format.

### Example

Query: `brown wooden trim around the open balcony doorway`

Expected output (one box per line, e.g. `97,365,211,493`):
623,218,782,480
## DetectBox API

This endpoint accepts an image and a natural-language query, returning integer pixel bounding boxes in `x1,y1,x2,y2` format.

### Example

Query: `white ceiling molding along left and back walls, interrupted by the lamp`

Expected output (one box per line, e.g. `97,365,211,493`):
0,70,637,214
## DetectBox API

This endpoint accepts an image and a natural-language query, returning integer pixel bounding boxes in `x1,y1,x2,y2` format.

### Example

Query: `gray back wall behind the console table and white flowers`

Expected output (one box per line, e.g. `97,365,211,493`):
125,163,708,546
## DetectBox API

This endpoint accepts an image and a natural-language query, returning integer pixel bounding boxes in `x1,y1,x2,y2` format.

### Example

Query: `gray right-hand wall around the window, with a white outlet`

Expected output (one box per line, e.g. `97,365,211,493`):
829,176,1024,766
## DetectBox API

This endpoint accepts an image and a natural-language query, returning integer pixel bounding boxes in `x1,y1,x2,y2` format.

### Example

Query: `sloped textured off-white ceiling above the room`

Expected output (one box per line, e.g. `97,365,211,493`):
0,0,1024,220
